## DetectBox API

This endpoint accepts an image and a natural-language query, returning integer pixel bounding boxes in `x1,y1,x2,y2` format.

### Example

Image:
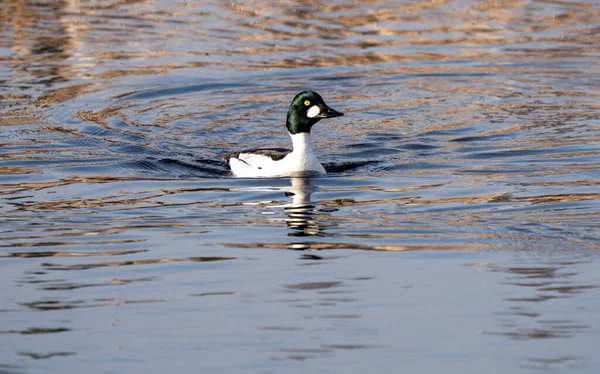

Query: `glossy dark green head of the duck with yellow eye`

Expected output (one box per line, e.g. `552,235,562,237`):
286,91,344,134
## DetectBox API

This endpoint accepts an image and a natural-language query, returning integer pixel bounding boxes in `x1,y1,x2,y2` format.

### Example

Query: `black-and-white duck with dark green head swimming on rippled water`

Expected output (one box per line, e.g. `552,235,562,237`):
227,91,344,178
